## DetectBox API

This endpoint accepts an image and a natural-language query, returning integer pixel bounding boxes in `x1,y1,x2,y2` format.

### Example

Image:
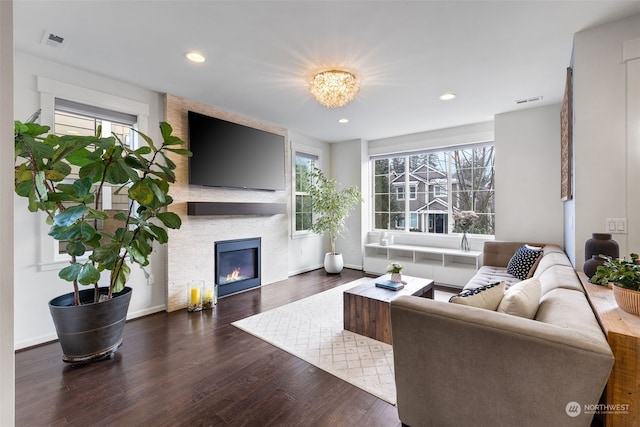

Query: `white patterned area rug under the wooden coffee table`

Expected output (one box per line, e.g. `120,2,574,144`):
233,278,396,405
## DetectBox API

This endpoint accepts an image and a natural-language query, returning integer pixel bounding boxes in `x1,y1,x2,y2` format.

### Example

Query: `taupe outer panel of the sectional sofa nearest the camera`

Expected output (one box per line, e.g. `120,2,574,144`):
391,296,613,427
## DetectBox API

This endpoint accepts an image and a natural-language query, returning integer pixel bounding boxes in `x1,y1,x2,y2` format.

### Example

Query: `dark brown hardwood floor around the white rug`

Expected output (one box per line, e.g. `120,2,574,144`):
16,270,400,426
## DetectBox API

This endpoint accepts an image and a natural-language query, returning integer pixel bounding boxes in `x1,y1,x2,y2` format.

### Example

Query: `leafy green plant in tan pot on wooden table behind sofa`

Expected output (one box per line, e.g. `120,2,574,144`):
591,253,640,315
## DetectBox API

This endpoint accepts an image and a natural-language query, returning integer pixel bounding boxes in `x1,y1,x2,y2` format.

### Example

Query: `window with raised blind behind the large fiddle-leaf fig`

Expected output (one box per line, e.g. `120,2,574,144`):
53,98,137,255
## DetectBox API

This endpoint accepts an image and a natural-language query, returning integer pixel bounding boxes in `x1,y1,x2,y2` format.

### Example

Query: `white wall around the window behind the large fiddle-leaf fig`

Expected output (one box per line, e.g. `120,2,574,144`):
13,51,166,348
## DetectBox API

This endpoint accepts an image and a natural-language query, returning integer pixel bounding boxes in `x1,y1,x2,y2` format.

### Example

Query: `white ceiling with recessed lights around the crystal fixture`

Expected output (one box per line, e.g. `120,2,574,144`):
14,0,640,142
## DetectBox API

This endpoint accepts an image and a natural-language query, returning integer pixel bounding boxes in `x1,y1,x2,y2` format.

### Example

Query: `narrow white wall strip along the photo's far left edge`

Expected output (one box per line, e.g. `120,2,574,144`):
0,0,15,426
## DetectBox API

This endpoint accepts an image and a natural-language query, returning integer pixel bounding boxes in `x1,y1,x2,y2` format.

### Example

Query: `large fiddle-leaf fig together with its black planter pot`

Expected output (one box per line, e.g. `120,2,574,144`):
14,115,190,363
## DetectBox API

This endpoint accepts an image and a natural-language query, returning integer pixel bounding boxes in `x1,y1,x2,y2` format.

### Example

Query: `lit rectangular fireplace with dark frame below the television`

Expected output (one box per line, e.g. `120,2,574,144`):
215,237,261,296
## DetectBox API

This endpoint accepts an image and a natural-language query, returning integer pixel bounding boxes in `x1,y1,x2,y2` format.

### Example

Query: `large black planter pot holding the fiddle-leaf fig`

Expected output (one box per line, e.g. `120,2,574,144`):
49,287,131,363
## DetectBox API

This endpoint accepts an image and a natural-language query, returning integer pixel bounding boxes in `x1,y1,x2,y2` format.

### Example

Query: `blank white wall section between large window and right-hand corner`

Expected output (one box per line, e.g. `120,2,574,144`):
495,104,564,246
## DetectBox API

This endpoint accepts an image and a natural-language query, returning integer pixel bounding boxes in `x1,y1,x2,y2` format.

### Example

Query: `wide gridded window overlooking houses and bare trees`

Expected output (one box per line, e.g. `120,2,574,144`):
371,143,495,235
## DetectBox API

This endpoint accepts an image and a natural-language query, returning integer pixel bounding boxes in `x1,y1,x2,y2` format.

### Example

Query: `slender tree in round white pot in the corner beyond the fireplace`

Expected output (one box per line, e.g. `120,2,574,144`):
307,168,362,273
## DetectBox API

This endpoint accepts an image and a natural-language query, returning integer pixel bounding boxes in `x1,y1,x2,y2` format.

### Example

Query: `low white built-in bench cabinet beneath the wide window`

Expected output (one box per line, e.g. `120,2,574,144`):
363,239,482,288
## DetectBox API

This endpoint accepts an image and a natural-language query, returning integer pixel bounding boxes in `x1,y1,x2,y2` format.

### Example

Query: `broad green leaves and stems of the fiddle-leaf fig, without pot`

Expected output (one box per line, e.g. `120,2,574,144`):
14,115,191,305
